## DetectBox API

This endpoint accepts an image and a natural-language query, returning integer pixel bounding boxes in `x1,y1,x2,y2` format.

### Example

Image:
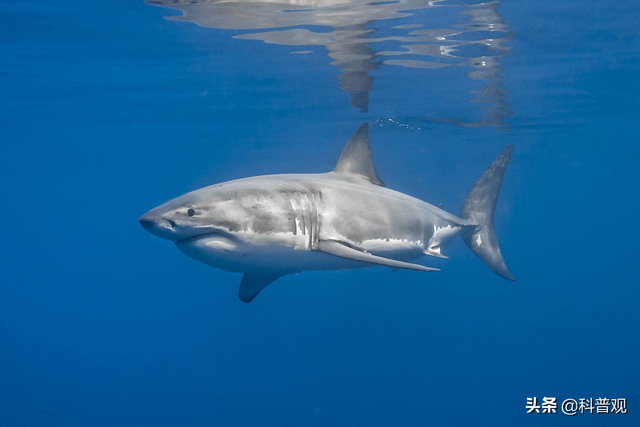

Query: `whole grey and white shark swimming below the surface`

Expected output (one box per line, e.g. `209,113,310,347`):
140,124,515,302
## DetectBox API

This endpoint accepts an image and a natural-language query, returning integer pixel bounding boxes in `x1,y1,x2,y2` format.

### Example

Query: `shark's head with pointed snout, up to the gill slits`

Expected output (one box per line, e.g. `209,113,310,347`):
140,181,295,271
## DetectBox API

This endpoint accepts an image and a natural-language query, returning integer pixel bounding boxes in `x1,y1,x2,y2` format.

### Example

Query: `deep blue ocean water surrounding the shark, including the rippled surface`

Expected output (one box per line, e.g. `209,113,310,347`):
0,0,640,427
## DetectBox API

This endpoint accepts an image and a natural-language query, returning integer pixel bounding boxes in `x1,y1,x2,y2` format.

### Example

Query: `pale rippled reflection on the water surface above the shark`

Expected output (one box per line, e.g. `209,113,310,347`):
147,0,512,127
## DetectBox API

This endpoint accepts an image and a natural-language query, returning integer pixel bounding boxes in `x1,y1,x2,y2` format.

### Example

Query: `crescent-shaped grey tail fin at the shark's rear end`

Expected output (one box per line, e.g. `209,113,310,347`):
460,145,516,280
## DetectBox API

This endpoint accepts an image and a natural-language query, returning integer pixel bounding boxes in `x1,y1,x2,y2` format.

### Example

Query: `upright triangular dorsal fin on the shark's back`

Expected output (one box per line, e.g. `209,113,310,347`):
333,123,384,187
